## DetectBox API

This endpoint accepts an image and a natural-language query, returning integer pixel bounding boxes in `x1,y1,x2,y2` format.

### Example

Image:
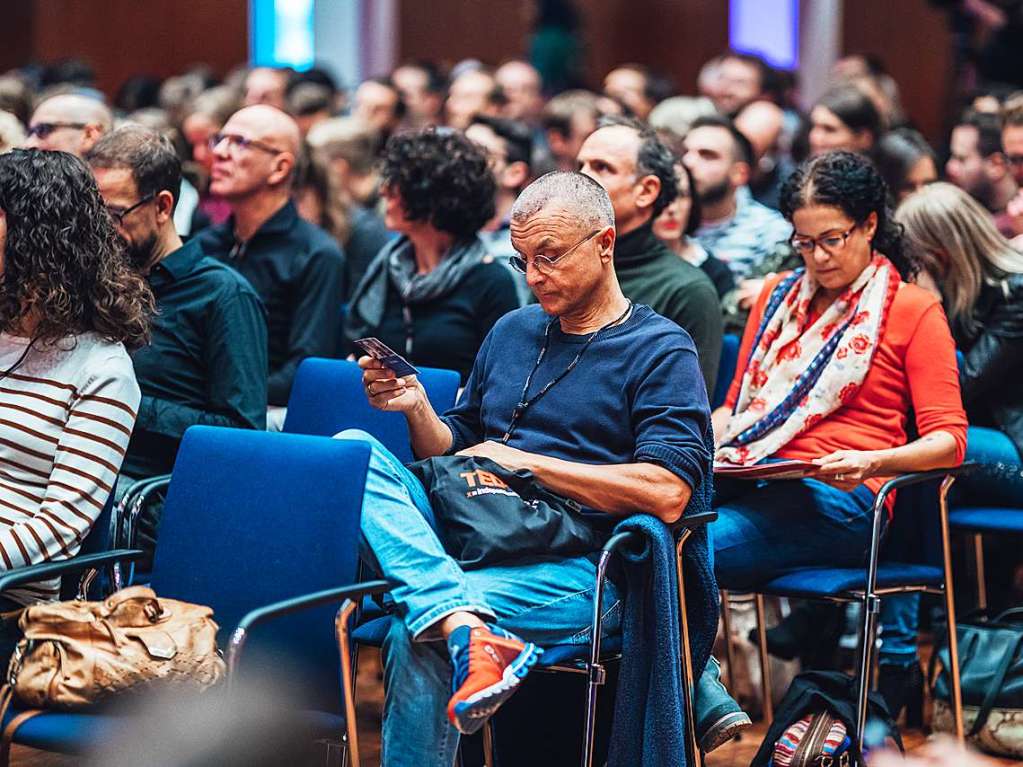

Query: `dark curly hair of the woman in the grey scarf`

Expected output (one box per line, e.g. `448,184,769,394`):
381,128,497,238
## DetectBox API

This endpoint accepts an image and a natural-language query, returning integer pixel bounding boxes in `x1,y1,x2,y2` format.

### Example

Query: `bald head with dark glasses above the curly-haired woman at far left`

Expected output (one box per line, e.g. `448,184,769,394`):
26,93,114,156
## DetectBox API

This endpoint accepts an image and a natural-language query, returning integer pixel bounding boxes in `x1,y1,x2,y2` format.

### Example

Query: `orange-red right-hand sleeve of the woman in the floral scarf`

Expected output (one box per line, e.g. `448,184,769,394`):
905,303,968,465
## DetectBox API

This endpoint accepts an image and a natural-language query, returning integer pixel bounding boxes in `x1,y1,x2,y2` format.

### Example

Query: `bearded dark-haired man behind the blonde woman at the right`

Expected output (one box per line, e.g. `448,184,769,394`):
945,111,1019,237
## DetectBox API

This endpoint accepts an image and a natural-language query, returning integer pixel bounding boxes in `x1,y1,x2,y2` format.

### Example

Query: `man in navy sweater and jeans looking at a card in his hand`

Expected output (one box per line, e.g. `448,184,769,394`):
340,172,711,767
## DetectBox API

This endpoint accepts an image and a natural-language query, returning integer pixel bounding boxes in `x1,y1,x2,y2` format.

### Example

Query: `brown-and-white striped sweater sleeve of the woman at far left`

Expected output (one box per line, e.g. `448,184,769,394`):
0,356,140,570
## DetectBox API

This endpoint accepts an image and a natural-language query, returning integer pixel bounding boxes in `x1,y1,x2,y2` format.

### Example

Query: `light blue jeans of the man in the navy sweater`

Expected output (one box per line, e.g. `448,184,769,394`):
337,430,621,767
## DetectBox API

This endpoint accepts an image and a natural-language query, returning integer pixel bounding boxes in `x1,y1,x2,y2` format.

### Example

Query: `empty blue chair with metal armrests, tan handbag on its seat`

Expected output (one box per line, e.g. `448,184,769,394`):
0,426,387,765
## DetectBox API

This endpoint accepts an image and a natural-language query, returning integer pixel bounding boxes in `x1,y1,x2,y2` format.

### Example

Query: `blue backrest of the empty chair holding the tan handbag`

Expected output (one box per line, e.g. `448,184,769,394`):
151,426,369,712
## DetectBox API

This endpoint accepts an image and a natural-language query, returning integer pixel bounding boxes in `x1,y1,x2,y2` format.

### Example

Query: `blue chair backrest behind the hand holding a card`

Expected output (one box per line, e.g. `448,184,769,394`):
283,358,459,463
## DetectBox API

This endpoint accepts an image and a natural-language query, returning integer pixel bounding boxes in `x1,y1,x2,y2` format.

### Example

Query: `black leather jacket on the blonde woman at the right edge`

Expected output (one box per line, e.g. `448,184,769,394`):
952,274,1023,454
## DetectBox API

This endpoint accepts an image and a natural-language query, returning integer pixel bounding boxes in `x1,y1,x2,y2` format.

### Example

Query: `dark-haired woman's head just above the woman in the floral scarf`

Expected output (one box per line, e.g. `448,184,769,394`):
809,85,883,157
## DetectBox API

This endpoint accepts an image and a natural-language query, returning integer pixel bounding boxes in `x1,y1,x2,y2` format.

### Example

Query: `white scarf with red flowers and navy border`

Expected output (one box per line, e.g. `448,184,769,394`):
714,255,900,466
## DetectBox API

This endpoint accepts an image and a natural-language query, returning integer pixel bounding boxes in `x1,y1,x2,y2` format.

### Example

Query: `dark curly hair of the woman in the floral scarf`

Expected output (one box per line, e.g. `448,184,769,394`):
782,151,920,280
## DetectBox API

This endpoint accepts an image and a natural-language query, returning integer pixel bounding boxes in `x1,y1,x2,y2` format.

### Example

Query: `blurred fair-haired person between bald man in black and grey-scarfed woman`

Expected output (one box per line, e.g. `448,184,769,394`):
309,118,392,301
